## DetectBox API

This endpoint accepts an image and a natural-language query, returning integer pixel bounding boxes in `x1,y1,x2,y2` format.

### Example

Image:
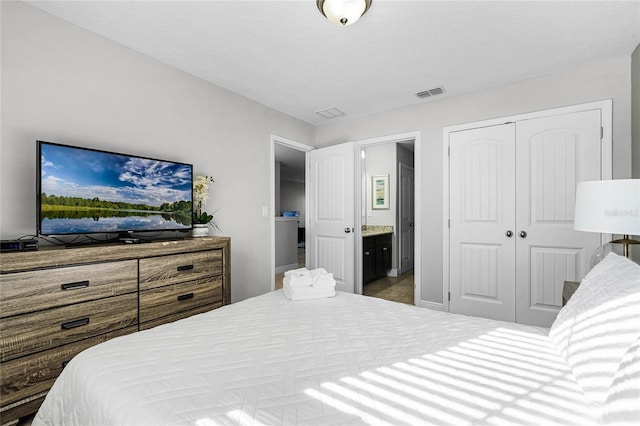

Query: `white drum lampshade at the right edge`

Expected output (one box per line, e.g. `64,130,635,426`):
573,179,640,235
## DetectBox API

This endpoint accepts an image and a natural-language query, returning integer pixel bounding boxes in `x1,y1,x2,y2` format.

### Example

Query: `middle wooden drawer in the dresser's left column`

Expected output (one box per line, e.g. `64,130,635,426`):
0,293,138,362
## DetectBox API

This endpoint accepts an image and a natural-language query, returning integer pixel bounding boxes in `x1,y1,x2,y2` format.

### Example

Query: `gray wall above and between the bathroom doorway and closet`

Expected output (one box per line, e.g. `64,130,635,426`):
316,57,631,303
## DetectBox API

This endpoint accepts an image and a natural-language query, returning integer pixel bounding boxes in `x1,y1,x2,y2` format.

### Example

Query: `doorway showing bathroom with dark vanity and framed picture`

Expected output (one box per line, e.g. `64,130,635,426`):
356,135,420,305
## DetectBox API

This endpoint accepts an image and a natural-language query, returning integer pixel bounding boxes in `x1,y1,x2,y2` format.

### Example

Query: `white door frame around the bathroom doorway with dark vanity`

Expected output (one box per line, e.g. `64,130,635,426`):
354,131,422,307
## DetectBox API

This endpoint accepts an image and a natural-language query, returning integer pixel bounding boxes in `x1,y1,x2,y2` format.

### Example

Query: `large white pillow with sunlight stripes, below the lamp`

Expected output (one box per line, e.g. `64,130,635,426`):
549,253,640,406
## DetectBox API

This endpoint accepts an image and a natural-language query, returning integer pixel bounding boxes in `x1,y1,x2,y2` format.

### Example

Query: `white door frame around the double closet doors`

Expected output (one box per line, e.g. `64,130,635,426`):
442,99,613,312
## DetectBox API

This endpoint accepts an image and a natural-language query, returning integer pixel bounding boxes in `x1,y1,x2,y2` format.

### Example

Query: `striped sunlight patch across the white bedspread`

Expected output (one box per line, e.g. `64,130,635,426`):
305,328,582,425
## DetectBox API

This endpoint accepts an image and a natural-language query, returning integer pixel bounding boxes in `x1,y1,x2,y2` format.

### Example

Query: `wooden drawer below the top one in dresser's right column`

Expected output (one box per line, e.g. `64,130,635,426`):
140,276,222,323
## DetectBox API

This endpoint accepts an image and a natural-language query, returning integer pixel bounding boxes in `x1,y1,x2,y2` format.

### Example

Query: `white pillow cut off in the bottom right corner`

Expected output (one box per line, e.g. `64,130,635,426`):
602,339,640,425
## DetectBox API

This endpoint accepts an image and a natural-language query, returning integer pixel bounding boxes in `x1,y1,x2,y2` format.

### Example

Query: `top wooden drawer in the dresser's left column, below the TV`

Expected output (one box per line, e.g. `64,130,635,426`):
0,260,138,317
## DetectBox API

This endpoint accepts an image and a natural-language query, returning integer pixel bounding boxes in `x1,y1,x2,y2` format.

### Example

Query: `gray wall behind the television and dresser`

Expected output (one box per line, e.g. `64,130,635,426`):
0,1,314,301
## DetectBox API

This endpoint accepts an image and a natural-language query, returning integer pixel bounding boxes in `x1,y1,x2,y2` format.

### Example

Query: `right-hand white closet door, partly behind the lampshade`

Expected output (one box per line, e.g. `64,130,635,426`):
516,110,601,327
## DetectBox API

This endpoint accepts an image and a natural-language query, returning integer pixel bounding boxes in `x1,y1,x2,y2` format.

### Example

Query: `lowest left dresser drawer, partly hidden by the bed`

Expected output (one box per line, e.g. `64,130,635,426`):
0,327,138,406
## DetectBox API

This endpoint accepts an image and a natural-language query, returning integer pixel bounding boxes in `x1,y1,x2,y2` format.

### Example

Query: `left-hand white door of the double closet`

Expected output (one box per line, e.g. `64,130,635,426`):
449,123,515,321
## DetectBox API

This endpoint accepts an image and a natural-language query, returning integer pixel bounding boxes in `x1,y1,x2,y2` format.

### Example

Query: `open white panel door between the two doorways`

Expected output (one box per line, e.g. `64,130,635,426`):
306,142,356,293
